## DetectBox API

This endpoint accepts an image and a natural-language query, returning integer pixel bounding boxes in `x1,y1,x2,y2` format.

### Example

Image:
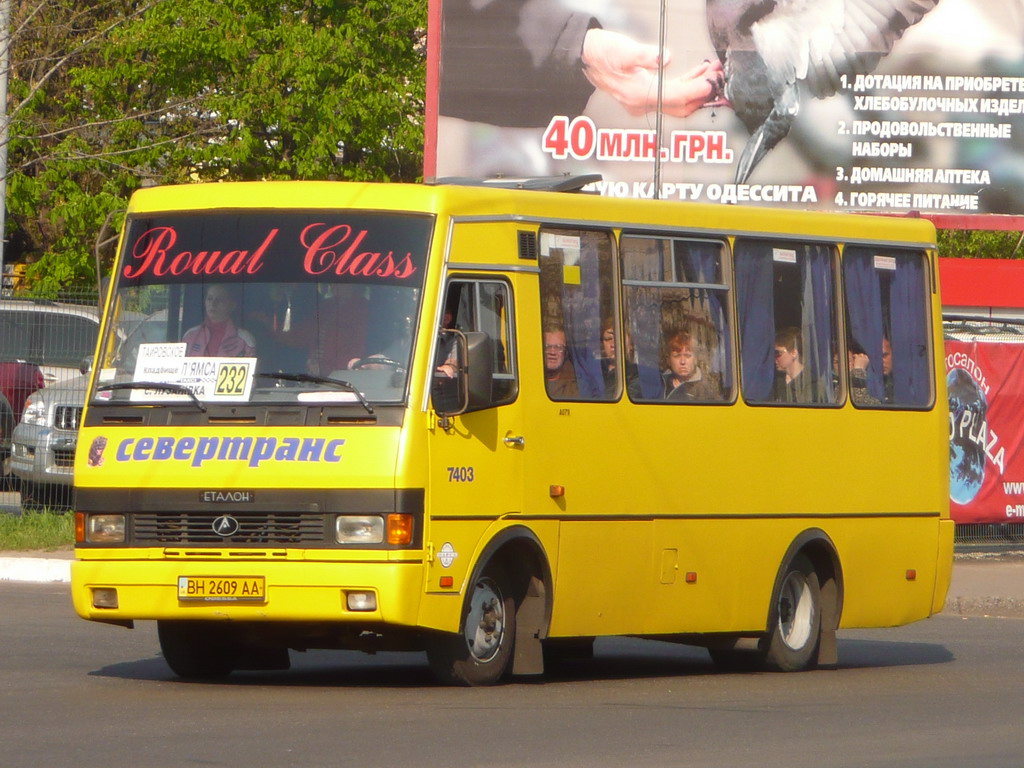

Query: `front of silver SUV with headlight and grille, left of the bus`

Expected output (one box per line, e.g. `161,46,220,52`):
10,376,89,508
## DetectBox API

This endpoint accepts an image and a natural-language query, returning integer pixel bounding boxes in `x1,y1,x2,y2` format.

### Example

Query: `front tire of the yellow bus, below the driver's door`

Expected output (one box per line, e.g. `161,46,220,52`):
427,565,516,686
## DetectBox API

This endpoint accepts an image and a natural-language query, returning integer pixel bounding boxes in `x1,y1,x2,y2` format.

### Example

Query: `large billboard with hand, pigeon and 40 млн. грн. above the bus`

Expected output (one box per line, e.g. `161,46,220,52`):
425,0,1024,214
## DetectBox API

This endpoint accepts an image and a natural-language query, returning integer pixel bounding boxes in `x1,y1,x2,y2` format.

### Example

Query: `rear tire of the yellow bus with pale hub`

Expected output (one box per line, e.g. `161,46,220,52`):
763,554,821,672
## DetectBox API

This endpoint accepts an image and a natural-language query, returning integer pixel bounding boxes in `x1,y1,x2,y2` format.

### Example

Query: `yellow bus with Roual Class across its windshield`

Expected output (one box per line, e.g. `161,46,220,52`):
72,179,953,685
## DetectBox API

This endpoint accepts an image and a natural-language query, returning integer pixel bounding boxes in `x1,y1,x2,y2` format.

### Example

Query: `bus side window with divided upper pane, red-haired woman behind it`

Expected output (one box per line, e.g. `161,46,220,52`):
621,234,733,403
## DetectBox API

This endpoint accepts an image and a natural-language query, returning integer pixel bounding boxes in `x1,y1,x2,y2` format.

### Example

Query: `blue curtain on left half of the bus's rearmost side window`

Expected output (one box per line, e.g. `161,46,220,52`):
843,248,886,402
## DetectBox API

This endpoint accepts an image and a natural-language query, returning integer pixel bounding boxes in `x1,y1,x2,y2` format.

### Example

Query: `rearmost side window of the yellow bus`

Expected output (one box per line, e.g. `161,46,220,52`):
843,246,933,408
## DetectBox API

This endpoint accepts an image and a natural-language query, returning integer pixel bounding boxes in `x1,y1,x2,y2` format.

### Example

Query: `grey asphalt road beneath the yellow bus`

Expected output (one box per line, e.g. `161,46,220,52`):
6,583,1024,768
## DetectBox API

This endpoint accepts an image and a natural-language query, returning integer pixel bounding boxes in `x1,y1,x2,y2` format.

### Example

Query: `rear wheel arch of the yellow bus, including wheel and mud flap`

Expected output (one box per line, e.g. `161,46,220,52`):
761,528,843,672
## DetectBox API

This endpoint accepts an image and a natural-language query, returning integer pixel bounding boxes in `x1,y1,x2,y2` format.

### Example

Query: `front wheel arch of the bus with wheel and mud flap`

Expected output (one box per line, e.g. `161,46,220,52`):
427,526,551,685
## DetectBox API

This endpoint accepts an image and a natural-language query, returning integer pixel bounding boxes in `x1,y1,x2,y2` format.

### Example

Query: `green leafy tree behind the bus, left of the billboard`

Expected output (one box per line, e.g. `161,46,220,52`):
8,0,426,292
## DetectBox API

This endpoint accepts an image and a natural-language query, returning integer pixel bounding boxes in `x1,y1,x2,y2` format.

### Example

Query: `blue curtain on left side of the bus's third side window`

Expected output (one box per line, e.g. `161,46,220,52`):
736,243,775,400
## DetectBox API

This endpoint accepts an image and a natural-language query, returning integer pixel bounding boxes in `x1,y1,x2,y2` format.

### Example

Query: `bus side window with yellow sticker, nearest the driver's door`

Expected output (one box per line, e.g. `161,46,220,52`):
539,228,622,400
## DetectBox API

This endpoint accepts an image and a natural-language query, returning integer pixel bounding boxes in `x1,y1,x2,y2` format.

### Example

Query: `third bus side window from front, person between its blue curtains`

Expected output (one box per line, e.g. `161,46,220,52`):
735,239,839,406
